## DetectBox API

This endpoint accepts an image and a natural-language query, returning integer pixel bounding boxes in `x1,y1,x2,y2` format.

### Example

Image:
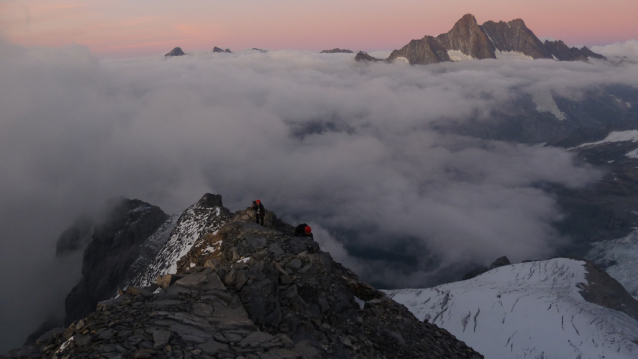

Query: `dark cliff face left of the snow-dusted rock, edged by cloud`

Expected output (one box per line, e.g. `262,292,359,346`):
65,200,168,323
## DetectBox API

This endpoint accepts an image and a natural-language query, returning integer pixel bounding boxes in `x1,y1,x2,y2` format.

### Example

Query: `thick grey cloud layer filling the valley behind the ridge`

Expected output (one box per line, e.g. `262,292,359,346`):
0,39,638,351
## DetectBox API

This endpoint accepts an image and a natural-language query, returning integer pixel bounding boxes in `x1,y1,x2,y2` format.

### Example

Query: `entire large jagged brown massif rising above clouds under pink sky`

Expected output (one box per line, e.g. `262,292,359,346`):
355,14,604,65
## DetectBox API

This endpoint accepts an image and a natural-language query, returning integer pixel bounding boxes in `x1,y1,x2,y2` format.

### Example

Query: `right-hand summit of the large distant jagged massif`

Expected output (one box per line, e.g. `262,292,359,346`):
481,19,552,59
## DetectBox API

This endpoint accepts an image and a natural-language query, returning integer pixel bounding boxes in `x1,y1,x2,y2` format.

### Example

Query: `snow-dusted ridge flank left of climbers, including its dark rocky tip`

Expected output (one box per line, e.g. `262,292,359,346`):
129,194,231,287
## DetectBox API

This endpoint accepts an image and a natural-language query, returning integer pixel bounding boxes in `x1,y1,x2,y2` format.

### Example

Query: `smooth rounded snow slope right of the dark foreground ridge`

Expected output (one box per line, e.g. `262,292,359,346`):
387,258,638,359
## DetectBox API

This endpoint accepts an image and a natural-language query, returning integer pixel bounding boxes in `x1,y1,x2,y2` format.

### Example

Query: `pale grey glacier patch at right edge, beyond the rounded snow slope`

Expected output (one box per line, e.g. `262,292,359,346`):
587,230,638,299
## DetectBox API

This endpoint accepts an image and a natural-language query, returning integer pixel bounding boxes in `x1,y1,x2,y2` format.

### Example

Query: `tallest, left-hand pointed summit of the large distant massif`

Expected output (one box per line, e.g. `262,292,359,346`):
436,14,496,59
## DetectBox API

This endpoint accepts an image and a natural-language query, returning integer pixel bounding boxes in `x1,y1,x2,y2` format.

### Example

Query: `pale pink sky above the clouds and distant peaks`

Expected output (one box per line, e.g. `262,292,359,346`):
0,0,638,57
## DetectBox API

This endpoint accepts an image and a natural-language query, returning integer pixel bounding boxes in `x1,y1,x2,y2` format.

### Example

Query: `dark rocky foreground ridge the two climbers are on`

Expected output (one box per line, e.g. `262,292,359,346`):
1,195,483,359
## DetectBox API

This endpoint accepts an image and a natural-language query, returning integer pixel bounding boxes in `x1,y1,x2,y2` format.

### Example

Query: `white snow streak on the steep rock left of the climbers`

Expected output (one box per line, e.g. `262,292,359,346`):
132,204,229,287
